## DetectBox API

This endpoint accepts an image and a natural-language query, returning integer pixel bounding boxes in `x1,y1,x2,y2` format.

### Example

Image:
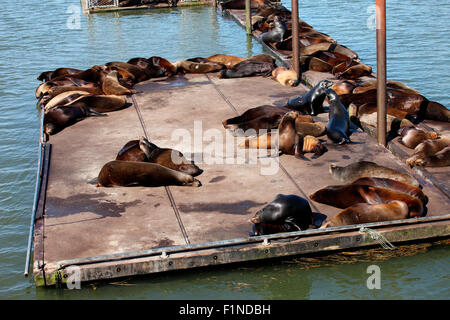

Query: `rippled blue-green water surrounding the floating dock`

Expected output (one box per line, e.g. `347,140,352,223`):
0,0,450,299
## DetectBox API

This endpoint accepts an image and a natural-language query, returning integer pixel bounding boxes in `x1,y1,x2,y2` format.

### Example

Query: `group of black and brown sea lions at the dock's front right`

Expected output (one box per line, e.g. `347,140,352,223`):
250,161,428,236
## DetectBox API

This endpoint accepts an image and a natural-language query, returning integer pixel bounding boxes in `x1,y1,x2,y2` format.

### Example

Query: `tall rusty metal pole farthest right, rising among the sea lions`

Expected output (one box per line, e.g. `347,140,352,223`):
376,0,387,146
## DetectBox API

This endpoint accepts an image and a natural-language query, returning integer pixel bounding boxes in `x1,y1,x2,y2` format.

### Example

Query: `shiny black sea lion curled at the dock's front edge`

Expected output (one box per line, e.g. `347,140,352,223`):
250,194,314,236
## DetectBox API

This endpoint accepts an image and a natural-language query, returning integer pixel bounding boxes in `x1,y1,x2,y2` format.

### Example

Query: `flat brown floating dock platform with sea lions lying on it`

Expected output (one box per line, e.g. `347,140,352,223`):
33,74,450,286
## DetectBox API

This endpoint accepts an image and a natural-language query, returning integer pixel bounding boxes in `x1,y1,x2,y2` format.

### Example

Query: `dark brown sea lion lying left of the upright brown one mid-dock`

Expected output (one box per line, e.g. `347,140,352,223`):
222,105,296,135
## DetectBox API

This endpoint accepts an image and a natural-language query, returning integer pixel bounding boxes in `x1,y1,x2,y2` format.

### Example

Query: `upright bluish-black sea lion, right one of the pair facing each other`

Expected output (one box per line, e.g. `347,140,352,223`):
325,88,352,144
